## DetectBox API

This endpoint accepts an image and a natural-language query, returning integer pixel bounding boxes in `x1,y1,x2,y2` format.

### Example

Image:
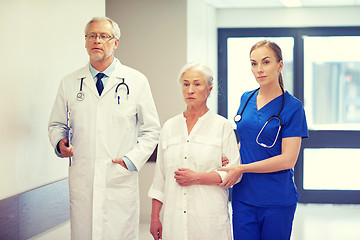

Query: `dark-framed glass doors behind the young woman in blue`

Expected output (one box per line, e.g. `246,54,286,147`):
218,27,360,203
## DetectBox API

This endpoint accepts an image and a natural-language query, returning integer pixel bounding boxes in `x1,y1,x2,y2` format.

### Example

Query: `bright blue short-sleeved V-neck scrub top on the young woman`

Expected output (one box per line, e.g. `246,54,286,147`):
233,91,308,207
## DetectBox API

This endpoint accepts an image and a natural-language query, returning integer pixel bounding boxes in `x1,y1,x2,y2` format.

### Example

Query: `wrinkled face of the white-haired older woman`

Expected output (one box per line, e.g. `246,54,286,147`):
181,69,212,107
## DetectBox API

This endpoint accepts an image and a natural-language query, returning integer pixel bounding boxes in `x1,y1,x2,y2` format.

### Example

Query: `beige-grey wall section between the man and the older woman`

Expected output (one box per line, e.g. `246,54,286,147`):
106,0,187,124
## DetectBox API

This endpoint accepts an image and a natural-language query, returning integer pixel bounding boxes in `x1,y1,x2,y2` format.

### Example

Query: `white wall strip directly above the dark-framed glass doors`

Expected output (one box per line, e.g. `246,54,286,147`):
217,7,360,28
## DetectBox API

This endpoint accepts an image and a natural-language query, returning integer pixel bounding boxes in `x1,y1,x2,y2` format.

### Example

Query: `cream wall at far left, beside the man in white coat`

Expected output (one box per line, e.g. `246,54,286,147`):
0,0,105,199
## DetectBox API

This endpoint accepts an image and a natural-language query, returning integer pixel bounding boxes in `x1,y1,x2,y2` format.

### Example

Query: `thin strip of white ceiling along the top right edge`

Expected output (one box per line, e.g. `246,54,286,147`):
203,0,360,8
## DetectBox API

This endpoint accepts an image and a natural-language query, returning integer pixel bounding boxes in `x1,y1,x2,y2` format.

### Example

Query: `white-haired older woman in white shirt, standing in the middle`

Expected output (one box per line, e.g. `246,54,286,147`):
148,63,240,240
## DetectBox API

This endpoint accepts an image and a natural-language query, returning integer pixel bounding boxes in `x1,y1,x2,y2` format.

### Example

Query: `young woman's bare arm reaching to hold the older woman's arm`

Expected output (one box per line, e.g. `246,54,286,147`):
218,137,301,187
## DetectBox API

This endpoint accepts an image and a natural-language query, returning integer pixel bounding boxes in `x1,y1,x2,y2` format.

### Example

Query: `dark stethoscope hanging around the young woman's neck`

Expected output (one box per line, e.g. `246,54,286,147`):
234,86,285,148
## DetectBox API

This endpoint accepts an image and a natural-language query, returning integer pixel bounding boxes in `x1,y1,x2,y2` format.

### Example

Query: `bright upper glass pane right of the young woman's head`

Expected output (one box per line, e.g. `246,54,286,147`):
304,36,360,130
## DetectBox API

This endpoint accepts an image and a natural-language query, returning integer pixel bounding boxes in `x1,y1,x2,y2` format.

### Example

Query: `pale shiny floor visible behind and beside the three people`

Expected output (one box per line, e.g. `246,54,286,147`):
31,204,360,240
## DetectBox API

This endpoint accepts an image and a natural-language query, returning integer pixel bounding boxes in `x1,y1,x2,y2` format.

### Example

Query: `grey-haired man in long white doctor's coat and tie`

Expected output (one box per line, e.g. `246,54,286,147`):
48,17,160,240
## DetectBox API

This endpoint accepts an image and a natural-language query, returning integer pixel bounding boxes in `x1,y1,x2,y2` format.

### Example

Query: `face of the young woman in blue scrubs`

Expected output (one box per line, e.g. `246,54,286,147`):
250,46,283,85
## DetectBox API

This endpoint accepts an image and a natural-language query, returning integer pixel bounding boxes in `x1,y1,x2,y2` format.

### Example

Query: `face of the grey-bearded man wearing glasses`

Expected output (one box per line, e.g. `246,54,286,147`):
85,21,119,61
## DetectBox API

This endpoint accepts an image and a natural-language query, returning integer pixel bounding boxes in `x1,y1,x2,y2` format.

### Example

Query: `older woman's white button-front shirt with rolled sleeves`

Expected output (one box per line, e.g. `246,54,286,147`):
148,111,240,240
